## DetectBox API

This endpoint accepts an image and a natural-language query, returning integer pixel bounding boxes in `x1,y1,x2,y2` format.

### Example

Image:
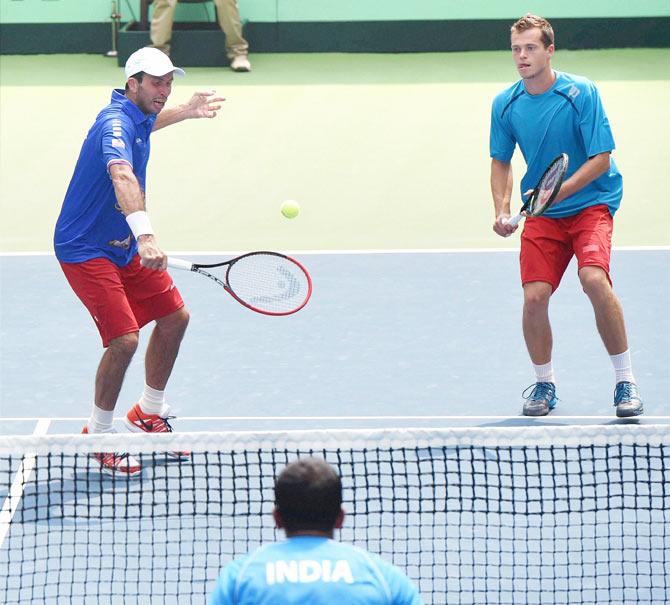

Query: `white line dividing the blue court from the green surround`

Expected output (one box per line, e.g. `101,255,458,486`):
0,246,670,256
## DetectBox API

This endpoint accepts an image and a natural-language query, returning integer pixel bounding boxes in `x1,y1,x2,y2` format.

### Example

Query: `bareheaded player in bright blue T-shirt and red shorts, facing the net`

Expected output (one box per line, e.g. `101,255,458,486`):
490,14,643,417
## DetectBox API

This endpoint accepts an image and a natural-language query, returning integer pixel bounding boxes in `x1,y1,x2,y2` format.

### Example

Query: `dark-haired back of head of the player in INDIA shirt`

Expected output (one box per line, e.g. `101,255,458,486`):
275,458,342,532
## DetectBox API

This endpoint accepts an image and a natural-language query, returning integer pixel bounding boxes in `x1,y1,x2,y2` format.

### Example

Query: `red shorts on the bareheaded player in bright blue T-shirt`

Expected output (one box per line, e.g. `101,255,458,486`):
520,205,613,291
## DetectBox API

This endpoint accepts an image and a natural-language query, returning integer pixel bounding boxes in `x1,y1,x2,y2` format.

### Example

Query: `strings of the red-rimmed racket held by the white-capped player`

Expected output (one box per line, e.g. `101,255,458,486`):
227,254,309,313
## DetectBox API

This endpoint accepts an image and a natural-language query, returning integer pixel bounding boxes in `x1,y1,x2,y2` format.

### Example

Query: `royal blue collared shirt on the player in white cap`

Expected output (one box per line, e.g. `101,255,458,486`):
54,90,156,267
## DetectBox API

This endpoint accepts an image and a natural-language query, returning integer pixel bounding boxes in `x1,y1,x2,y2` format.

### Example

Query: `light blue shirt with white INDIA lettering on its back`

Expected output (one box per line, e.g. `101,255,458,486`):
210,536,422,605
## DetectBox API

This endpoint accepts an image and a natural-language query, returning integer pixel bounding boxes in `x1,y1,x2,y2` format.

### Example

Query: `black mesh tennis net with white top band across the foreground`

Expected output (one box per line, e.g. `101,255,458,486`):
0,425,670,605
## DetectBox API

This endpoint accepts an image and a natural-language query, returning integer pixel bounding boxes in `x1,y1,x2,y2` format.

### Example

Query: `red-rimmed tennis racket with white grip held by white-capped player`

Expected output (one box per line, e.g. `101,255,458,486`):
168,252,312,315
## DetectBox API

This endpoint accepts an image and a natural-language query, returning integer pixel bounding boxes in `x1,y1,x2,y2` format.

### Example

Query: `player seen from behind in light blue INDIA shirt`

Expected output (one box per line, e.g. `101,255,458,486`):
210,458,422,605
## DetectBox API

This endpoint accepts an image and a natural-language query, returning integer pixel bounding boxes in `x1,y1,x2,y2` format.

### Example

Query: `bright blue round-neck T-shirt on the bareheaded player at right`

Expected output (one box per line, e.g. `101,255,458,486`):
490,72,623,218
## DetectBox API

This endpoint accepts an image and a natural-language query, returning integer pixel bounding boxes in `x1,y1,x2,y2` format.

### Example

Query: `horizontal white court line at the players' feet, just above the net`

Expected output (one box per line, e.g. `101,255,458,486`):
2,414,670,422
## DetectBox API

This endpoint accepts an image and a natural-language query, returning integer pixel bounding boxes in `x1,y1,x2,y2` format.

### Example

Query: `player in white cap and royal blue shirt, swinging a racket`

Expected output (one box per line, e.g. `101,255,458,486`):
54,48,223,476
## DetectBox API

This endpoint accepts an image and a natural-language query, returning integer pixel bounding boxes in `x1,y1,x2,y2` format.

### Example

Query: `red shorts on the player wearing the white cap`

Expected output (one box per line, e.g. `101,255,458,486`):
60,255,184,347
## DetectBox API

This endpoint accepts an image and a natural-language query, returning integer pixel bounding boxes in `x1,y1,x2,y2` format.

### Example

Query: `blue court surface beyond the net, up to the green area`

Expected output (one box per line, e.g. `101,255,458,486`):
0,249,670,433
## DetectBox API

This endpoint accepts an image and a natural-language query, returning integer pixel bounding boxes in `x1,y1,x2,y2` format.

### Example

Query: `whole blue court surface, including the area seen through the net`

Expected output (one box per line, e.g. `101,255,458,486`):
0,249,670,605
